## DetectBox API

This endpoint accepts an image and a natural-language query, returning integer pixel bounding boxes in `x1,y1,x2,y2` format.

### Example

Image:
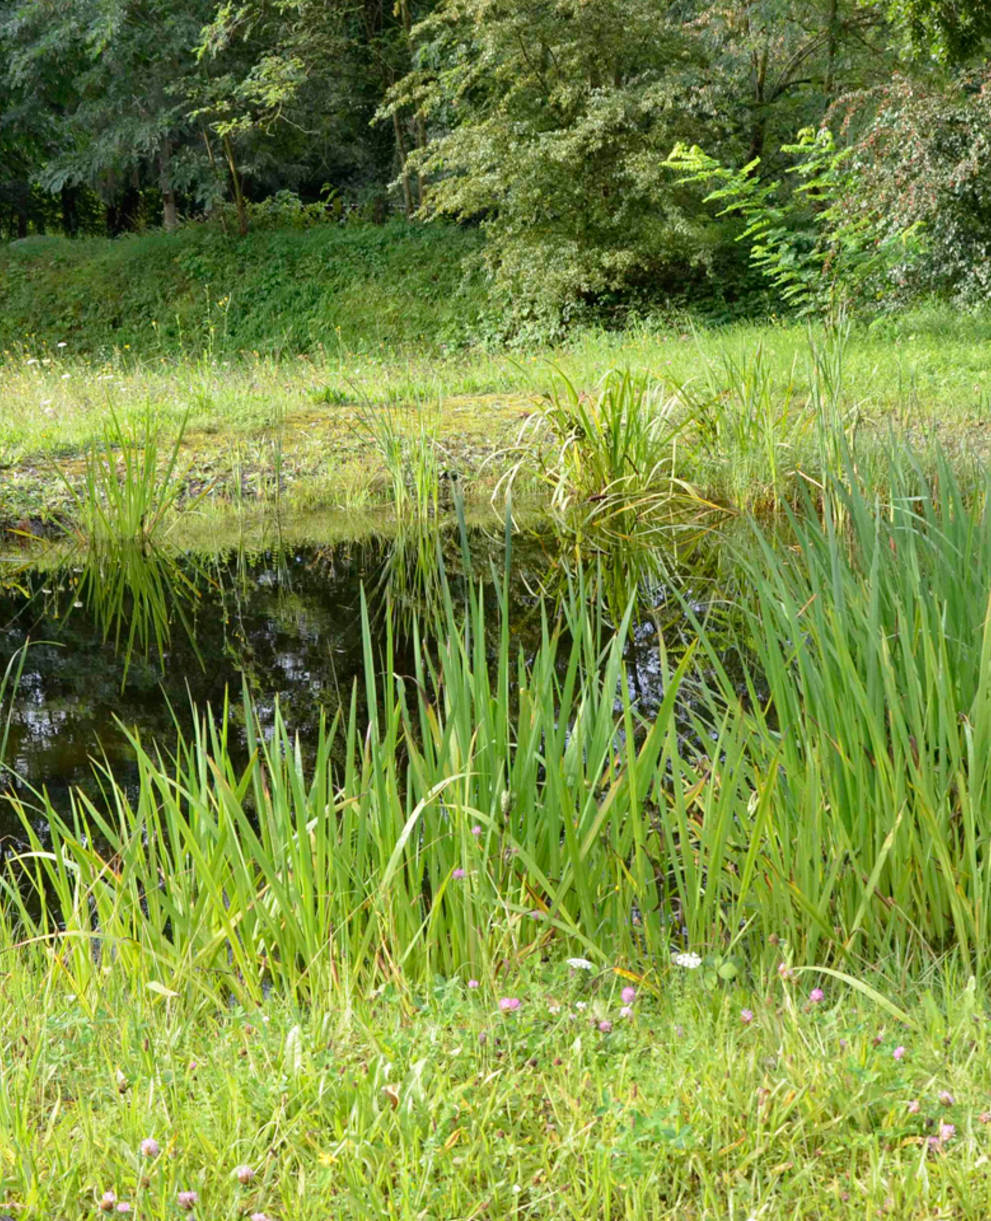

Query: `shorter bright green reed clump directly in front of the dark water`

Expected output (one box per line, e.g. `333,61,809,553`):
1,566,676,999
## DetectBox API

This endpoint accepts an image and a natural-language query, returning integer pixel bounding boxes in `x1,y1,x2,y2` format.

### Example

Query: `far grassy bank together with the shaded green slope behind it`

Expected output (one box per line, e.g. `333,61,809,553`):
0,226,991,534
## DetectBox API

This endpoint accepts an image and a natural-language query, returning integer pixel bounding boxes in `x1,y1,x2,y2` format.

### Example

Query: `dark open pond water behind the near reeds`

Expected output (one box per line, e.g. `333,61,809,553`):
0,532,717,838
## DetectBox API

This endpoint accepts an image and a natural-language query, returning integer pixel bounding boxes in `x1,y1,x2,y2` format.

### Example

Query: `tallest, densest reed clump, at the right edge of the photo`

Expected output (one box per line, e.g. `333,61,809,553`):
693,458,991,973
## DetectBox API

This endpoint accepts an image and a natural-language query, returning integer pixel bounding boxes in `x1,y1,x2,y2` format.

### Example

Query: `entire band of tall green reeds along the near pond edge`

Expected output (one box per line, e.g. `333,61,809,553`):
5,449,991,999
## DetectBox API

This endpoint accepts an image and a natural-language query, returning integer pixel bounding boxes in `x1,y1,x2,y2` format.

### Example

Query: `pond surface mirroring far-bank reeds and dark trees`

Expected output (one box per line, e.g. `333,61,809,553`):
0,526,737,835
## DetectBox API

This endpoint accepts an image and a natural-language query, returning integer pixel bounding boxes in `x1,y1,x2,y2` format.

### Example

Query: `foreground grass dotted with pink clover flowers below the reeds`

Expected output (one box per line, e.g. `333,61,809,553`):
7,951,991,1221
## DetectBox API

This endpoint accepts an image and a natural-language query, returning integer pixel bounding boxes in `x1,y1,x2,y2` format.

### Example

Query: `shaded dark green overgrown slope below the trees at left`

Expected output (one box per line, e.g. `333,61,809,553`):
0,221,480,358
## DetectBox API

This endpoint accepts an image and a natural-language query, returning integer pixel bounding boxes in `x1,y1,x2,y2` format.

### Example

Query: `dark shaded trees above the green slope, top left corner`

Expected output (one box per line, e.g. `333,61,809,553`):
0,0,410,236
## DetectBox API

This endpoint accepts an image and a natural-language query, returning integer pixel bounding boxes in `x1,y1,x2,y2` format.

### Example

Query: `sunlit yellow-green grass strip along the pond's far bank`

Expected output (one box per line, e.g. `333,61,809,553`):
0,311,991,532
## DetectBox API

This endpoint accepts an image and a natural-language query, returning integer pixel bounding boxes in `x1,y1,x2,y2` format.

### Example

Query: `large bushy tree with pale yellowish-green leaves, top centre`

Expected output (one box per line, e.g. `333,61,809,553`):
381,0,719,328
